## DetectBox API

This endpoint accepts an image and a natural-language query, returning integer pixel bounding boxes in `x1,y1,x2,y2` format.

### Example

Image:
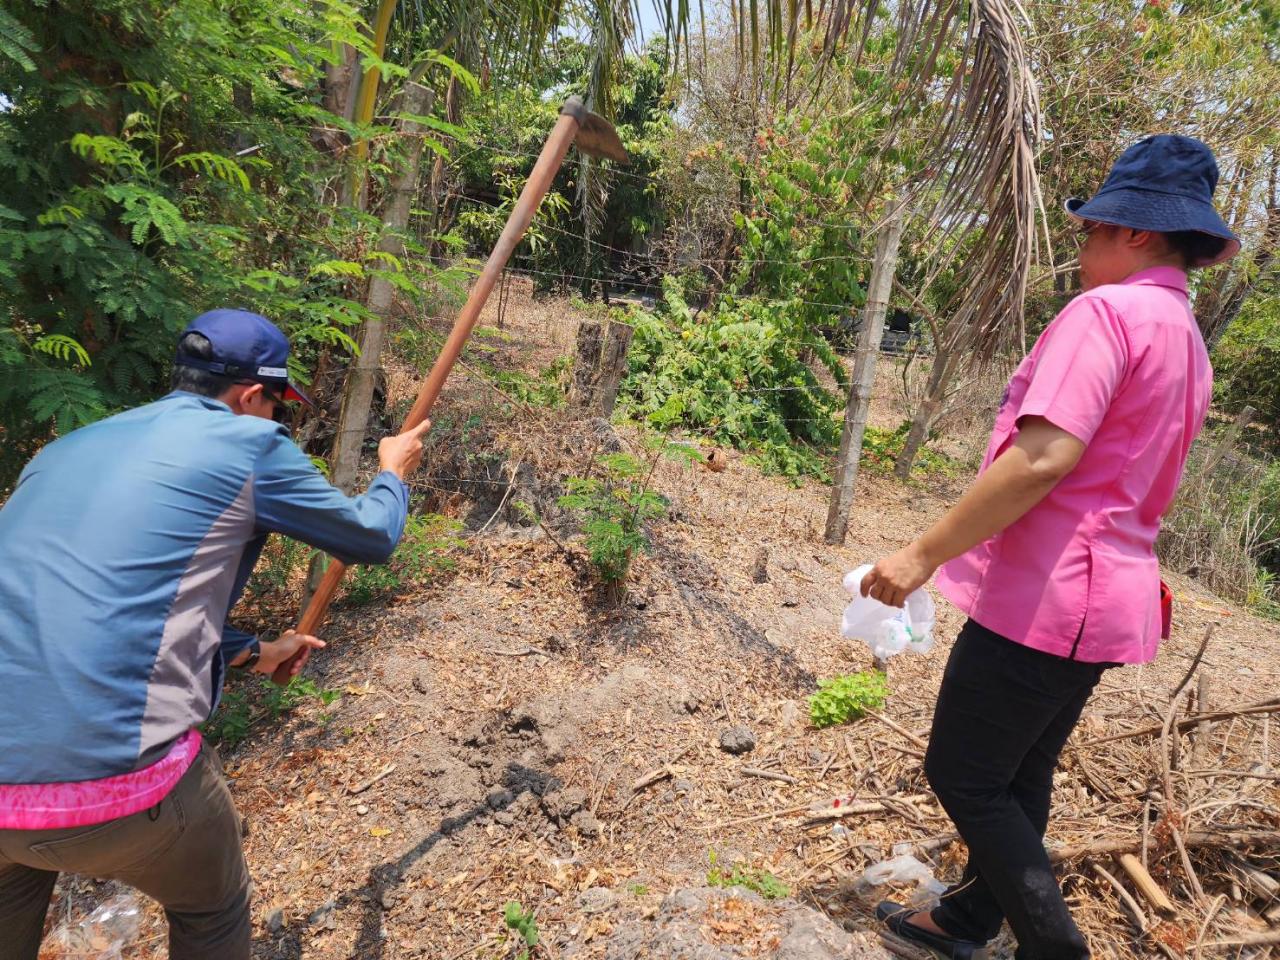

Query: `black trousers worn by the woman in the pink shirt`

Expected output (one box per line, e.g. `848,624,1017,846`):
924,621,1115,960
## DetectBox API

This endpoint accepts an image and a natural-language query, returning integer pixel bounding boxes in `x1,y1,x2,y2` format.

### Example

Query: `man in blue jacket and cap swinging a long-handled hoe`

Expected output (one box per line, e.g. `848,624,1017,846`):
0,310,428,960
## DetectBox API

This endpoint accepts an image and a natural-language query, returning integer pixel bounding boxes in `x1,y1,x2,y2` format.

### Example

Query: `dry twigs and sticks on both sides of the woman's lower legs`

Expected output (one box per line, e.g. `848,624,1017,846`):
806,627,1280,957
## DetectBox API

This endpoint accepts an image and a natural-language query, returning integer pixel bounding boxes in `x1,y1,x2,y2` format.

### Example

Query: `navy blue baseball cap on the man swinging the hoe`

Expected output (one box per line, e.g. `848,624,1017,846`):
173,310,315,407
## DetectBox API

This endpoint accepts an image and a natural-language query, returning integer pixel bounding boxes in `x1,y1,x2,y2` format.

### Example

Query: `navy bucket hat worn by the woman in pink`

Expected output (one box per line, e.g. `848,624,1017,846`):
1066,133,1240,266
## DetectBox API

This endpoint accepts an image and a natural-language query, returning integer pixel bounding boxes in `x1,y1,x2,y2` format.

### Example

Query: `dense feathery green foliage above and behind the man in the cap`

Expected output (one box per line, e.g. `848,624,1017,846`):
0,0,468,495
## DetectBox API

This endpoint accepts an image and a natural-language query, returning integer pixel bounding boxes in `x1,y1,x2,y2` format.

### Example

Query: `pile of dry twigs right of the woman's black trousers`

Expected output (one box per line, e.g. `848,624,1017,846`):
1053,627,1280,957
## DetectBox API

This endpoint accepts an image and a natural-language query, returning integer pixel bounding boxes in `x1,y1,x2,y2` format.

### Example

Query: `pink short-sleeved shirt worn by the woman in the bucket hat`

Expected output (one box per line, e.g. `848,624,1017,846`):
937,266,1213,663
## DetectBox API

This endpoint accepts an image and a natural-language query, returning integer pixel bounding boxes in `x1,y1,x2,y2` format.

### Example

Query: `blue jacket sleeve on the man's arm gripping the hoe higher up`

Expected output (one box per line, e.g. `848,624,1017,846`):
253,428,408,563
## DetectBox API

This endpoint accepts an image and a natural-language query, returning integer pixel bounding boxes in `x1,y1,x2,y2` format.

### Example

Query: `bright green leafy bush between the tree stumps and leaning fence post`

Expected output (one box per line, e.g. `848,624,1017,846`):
620,278,844,477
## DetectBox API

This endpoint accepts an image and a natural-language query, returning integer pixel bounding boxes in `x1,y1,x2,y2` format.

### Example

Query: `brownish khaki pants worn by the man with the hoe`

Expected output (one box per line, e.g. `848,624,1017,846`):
0,744,250,960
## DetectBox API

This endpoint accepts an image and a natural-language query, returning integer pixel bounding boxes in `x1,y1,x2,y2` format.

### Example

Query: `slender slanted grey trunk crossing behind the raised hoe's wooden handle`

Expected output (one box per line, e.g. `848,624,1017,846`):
302,83,431,608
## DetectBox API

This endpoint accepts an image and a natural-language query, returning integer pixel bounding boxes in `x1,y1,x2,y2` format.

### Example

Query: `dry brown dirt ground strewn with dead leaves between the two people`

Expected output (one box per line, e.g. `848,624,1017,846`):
47,288,1280,960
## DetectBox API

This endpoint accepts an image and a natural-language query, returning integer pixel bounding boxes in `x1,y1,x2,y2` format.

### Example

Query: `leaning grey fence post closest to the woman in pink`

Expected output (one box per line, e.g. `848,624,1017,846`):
826,200,905,544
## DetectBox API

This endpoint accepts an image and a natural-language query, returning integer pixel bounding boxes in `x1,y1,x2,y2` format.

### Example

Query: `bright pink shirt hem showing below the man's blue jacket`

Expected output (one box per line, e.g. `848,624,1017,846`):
0,730,202,829
